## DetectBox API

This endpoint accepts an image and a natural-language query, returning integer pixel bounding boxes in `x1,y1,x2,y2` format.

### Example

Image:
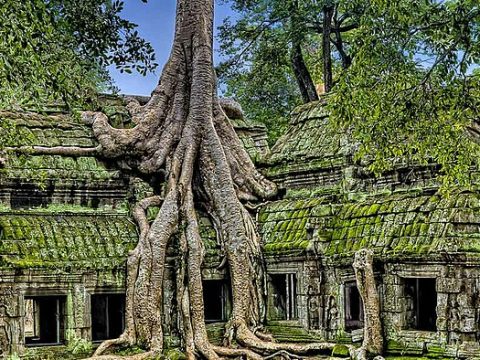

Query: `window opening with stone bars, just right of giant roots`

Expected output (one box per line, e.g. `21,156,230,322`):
270,273,298,320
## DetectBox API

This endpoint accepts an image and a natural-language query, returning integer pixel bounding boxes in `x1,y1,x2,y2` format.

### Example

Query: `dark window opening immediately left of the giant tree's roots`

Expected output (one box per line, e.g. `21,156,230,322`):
91,294,125,341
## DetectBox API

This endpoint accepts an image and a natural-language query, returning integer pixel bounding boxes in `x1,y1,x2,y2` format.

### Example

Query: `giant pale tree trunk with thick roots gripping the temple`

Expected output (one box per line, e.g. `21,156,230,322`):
78,0,333,359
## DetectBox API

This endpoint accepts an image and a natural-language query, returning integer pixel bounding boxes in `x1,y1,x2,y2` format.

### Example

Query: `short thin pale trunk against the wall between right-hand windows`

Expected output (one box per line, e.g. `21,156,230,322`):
353,249,383,358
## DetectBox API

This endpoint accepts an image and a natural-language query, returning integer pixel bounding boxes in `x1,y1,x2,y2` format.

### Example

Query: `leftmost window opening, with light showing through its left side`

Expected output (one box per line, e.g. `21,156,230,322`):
24,296,65,346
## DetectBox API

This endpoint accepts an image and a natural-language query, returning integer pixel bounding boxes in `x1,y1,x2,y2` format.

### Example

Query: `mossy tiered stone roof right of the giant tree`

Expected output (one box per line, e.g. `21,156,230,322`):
258,98,480,262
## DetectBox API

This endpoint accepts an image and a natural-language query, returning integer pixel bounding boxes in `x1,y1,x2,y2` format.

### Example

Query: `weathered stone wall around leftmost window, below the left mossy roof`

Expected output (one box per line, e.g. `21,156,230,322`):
0,269,125,359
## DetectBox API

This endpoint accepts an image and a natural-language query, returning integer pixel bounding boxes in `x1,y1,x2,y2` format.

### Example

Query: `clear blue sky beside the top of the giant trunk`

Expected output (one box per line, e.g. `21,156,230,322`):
110,0,233,95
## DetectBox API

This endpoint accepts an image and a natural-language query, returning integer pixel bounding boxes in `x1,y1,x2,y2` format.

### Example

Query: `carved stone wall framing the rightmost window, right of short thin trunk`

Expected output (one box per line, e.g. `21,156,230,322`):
383,263,480,357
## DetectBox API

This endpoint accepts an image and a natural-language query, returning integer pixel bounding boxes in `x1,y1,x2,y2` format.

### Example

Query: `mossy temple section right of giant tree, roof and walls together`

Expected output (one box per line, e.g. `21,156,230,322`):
257,97,480,358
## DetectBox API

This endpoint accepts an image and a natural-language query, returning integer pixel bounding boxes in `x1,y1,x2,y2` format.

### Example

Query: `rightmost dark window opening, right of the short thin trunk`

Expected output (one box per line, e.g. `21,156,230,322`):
404,278,437,331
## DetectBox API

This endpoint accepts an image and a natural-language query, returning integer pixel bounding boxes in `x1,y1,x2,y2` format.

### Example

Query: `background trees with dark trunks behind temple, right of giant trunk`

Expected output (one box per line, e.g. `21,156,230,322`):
218,0,360,142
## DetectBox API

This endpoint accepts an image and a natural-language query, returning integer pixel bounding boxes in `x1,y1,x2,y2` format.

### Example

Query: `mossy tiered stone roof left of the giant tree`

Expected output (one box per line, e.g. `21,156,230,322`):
0,107,137,269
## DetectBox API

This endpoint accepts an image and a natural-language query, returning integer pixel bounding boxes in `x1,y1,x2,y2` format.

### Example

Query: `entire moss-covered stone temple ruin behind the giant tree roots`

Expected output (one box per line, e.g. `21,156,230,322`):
0,98,480,359
